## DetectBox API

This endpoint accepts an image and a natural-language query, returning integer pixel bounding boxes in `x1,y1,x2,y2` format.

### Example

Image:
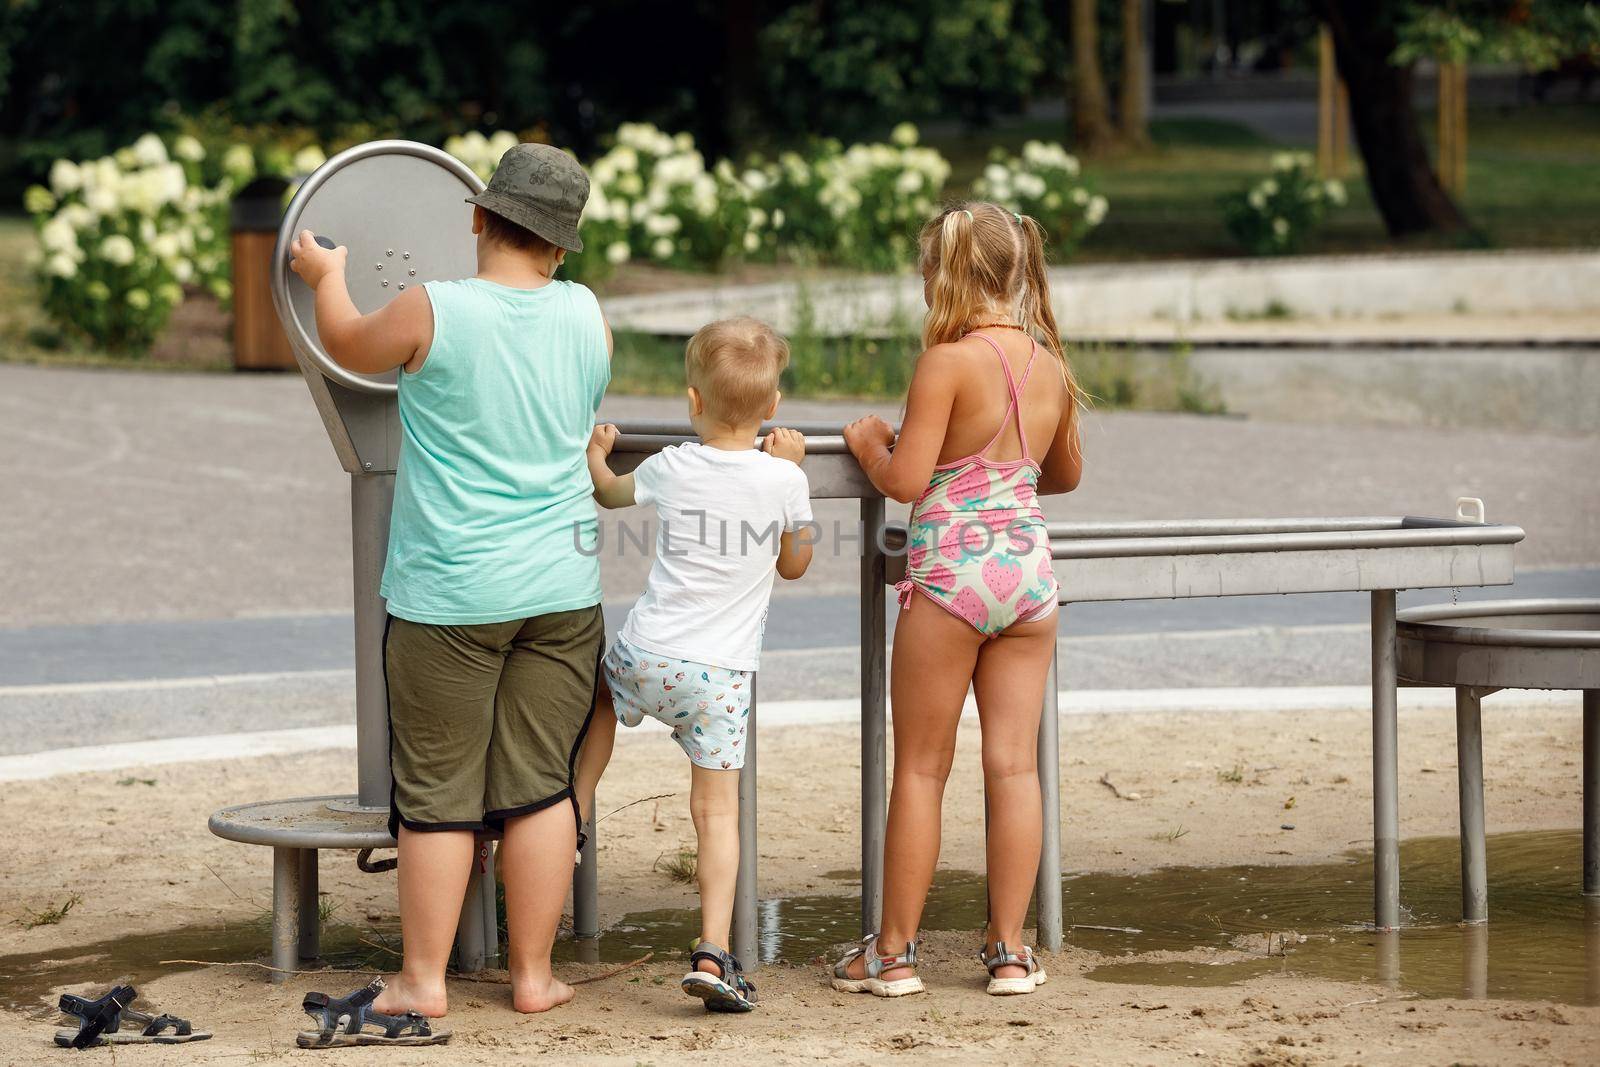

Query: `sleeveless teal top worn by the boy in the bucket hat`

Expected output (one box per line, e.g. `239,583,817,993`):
381,278,611,625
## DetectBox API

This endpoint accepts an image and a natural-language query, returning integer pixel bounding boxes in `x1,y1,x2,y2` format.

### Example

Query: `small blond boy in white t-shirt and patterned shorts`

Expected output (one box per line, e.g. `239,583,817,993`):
578,318,811,1011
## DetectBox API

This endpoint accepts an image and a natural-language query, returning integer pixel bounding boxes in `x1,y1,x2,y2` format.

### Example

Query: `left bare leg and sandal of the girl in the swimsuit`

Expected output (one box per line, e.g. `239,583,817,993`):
850,593,979,981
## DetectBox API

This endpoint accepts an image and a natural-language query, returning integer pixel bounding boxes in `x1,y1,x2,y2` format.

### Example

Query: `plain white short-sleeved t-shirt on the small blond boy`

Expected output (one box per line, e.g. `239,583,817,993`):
621,443,811,670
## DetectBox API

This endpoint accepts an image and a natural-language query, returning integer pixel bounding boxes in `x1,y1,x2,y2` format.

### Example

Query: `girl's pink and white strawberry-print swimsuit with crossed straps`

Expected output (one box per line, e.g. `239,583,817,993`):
894,333,1058,637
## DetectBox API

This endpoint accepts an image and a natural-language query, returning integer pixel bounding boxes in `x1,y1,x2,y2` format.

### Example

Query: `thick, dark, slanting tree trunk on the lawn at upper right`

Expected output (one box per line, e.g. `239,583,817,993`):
1317,0,1467,237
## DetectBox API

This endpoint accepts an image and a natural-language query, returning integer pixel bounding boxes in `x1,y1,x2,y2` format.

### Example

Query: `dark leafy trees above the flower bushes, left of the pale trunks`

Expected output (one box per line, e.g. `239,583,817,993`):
0,0,1066,174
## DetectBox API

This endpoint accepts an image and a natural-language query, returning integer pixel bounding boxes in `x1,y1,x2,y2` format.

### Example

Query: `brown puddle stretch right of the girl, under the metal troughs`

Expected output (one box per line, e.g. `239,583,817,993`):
1067,830,1600,1003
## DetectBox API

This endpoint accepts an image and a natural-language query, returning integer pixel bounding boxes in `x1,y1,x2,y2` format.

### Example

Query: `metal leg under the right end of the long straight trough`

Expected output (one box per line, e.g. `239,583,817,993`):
1373,589,1400,929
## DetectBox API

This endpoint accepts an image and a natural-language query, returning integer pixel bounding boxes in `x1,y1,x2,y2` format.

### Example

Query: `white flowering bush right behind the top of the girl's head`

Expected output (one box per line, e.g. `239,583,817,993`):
973,141,1110,259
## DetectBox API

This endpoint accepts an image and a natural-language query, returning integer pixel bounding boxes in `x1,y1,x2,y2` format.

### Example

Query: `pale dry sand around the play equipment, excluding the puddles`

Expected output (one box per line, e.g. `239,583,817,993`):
0,697,1600,1064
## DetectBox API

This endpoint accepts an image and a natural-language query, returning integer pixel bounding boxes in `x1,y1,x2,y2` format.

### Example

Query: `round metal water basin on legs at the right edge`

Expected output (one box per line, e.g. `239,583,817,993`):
1397,600,1600,923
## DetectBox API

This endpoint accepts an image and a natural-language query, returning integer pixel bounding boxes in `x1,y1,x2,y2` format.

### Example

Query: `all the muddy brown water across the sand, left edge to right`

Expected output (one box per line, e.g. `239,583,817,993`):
0,830,1600,1009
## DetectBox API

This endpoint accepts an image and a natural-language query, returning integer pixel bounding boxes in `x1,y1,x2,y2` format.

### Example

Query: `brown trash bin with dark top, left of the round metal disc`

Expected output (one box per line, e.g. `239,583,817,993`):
229,178,296,371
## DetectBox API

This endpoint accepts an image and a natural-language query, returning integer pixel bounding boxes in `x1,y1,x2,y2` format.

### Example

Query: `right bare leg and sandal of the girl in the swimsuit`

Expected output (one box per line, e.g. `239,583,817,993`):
973,613,1056,977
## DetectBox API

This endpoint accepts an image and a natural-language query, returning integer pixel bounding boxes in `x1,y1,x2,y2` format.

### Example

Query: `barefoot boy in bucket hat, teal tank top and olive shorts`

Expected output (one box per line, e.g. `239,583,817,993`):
291,144,611,1016
